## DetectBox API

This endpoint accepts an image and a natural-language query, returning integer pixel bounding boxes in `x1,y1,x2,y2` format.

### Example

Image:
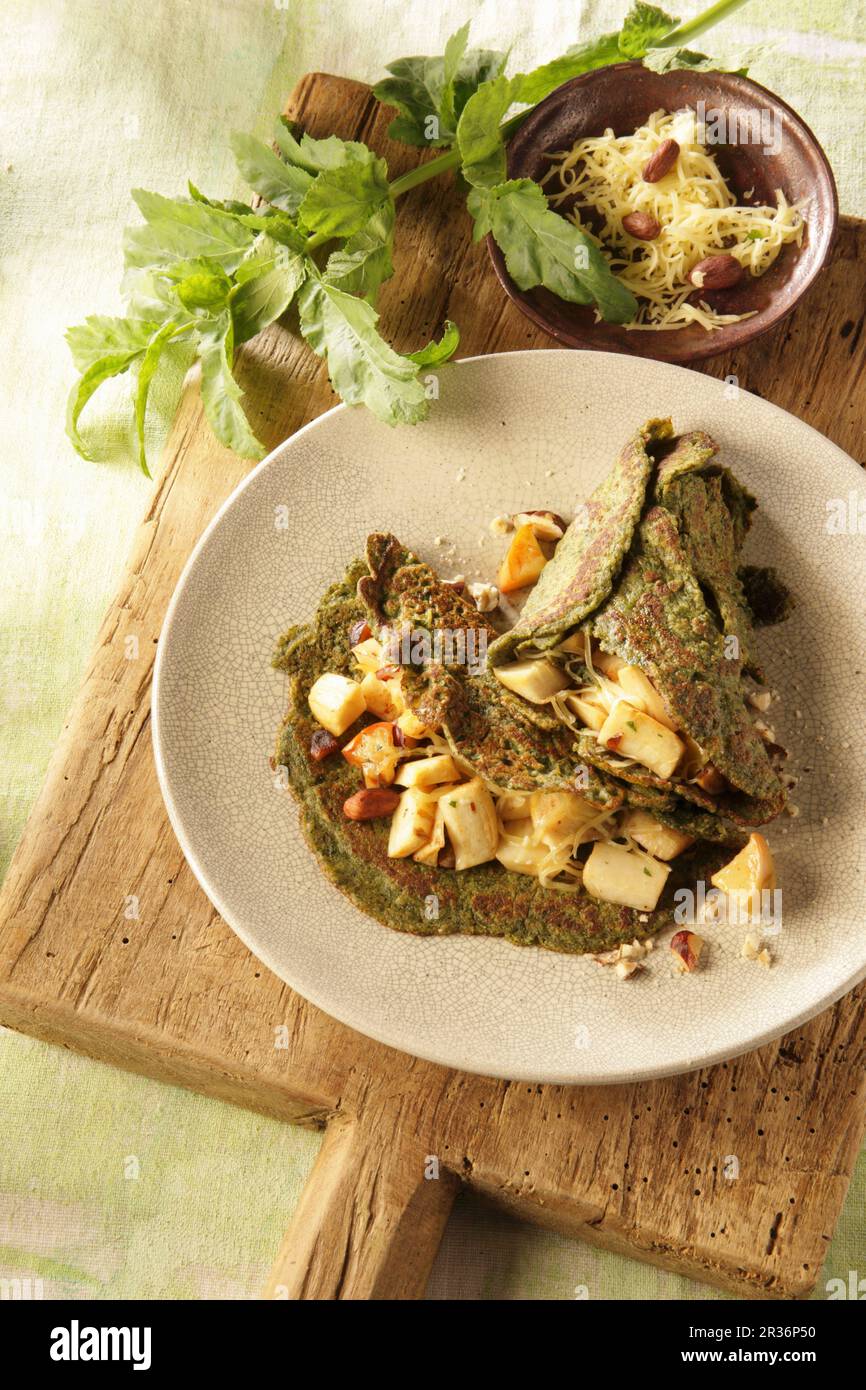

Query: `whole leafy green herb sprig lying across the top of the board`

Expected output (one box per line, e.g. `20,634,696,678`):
67,0,744,475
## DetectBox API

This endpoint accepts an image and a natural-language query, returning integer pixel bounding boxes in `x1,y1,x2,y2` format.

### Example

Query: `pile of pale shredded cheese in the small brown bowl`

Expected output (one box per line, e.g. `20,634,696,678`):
542,110,803,329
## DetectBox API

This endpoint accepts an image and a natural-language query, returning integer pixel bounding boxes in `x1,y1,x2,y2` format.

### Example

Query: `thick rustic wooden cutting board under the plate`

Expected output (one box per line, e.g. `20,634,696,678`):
0,74,866,1298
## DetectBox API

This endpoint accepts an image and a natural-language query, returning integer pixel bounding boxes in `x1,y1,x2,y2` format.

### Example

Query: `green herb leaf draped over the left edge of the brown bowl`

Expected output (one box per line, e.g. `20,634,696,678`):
484,178,638,324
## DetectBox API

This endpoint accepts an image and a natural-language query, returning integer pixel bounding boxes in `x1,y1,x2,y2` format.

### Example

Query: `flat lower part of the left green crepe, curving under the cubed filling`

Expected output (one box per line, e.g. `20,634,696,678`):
274,550,730,952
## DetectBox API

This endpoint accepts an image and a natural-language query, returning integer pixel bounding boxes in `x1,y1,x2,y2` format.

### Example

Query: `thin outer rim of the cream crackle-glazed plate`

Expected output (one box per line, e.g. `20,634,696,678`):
150,348,866,1086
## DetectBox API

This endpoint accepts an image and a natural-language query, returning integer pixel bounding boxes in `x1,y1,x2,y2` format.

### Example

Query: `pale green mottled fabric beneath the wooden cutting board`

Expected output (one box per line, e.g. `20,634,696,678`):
0,0,866,1298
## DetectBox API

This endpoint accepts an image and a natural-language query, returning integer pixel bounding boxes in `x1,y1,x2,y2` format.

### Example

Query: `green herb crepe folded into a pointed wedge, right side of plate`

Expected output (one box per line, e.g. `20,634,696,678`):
489,420,787,824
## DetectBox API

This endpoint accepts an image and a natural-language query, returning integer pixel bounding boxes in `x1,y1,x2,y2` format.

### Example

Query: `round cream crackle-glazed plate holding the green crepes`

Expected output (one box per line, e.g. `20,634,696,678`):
153,350,866,1084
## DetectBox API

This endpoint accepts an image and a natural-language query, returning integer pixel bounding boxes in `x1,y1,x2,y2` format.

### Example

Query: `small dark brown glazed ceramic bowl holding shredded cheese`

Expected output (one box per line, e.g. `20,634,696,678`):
488,63,838,363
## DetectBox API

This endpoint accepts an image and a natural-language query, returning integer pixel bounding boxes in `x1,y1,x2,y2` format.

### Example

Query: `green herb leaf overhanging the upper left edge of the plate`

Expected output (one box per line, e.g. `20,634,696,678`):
297,275,428,425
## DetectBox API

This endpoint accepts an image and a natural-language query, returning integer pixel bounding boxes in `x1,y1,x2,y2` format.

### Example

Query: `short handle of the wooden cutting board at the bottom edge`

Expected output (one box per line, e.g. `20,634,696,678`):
264,1098,460,1300
